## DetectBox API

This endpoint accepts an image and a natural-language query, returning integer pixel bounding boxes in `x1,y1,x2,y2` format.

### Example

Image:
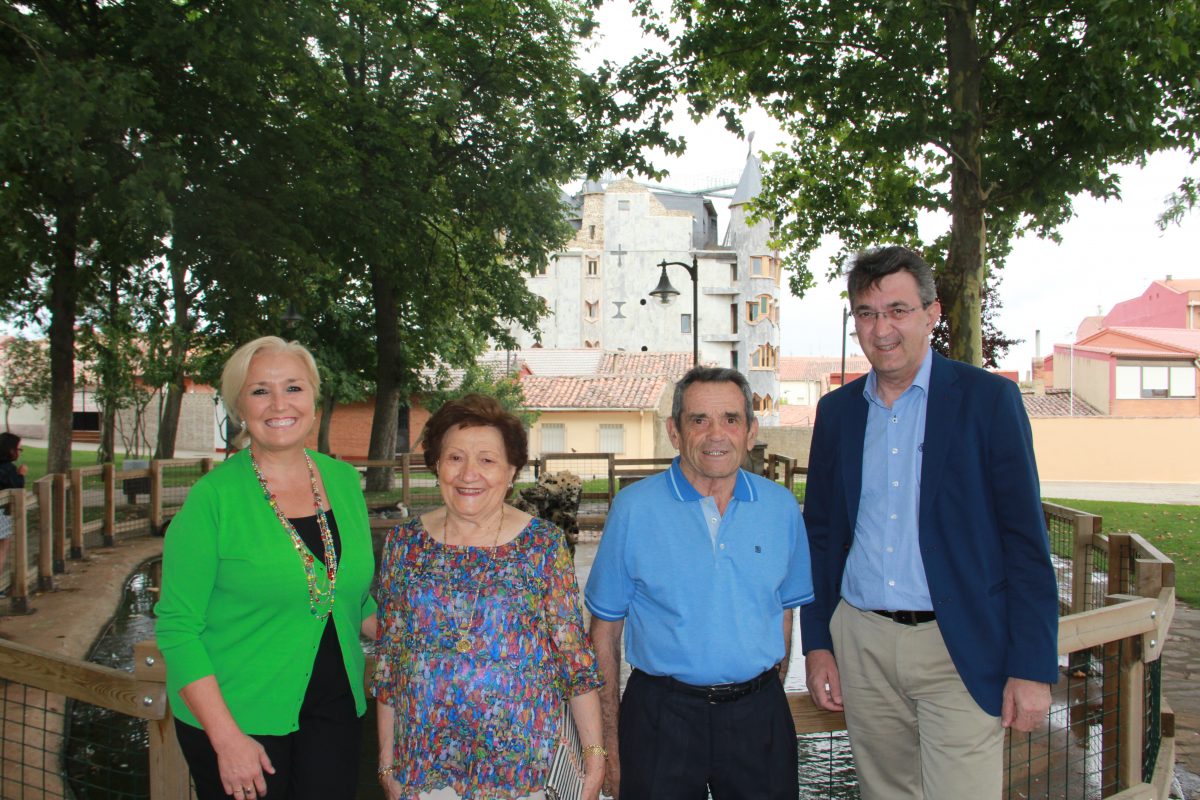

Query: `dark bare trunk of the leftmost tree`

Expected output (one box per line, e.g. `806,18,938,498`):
46,204,79,474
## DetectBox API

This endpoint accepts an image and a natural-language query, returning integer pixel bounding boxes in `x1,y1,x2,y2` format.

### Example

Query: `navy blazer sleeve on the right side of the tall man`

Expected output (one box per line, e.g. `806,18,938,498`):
988,381,1058,684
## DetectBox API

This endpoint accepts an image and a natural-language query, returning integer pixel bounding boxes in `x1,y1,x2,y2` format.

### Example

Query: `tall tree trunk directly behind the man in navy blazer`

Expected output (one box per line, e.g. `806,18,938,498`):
938,0,986,366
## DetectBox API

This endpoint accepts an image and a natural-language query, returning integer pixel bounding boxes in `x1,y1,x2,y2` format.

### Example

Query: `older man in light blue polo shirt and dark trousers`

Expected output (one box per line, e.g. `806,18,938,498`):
584,367,812,800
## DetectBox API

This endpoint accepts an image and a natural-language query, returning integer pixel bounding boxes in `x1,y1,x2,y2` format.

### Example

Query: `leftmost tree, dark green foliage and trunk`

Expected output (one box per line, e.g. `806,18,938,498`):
0,1,174,473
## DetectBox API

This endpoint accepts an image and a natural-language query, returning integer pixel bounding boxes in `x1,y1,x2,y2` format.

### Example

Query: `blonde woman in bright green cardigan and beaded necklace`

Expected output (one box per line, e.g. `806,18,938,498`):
156,337,376,800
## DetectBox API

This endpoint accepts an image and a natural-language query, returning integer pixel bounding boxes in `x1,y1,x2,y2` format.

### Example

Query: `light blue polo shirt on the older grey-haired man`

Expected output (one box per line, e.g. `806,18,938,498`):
584,457,812,686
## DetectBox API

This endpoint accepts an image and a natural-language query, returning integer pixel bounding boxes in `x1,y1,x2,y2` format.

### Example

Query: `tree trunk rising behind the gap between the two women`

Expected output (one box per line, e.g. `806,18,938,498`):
366,267,400,492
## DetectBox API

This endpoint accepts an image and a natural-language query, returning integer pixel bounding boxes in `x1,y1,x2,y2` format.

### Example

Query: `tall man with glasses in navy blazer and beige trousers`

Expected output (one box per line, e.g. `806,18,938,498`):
800,247,1058,800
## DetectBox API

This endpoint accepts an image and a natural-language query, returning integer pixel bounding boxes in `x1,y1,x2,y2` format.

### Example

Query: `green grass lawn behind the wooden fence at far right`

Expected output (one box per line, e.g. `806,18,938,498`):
1046,498,1200,607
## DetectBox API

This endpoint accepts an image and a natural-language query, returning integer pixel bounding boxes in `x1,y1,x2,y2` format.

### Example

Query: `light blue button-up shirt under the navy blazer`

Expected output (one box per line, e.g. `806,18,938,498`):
841,350,934,610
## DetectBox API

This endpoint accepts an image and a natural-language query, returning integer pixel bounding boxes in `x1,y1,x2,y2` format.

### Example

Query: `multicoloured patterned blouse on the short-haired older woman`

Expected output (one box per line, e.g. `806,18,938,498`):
372,518,602,800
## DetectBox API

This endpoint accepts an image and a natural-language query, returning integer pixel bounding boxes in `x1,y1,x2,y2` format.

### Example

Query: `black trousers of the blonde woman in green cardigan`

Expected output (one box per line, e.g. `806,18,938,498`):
175,620,362,800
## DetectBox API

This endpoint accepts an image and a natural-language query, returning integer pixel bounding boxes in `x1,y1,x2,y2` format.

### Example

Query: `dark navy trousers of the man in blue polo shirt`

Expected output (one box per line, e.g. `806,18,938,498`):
619,669,799,800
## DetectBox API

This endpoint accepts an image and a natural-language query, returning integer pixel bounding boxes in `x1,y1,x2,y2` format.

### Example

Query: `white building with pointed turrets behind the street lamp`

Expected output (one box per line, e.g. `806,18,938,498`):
514,156,780,425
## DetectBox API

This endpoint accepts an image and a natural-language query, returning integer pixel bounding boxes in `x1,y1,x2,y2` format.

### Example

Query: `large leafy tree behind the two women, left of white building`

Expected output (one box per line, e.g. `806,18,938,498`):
306,0,604,489
